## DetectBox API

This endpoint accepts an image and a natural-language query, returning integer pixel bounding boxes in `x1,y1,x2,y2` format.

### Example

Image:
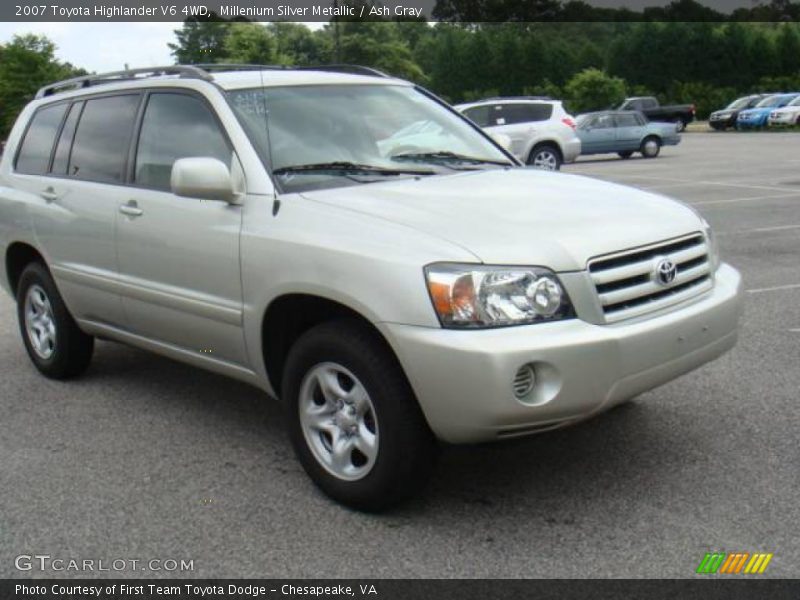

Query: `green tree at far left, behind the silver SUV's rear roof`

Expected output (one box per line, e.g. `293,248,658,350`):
0,34,86,139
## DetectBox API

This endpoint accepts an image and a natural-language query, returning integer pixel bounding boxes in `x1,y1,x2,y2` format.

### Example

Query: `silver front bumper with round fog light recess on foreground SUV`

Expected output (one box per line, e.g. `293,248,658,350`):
383,265,742,443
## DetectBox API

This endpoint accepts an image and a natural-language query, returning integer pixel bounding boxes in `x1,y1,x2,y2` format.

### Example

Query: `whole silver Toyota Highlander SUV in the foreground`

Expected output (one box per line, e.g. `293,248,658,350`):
0,66,740,510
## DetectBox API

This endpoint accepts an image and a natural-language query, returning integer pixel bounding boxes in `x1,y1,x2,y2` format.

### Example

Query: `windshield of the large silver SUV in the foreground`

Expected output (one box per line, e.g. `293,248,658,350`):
228,85,511,191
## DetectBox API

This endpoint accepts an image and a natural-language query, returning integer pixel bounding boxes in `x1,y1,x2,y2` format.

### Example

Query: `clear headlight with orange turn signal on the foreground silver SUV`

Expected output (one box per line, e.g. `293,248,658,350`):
425,263,575,328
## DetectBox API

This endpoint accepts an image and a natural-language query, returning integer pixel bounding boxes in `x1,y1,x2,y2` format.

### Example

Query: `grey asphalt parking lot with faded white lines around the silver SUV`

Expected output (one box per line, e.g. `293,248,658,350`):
0,133,800,578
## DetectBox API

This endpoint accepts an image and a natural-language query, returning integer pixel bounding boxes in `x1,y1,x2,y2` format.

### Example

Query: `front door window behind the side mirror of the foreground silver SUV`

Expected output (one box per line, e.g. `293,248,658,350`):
134,93,231,190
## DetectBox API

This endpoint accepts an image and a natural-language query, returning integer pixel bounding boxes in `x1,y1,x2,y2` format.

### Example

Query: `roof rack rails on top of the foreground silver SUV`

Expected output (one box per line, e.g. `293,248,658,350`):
36,63,389,98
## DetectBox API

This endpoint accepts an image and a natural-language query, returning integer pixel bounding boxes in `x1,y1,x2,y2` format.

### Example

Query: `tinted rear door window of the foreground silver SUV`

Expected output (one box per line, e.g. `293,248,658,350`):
68,94,139,183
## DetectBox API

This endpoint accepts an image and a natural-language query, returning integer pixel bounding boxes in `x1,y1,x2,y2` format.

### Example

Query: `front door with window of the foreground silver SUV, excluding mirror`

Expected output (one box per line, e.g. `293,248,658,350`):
116,90,246,365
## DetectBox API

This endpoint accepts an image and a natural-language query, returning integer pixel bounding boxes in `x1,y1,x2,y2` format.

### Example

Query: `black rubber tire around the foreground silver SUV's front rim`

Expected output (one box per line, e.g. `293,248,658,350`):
282,320,437,512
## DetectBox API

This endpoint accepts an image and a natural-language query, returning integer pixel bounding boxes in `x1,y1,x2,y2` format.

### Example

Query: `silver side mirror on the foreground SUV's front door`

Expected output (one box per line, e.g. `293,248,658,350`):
170,157,237,204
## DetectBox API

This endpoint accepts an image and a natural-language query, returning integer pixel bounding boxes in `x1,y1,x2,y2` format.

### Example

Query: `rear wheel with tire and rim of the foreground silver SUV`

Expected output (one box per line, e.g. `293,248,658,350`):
17,262,94,379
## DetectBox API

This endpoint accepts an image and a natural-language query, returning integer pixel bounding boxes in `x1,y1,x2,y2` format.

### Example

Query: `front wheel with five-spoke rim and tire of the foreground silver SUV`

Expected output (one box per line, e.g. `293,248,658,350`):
283,320,436,511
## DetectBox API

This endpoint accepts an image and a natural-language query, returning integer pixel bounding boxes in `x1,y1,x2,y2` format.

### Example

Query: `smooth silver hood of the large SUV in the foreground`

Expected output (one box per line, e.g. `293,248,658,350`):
302,168,702,271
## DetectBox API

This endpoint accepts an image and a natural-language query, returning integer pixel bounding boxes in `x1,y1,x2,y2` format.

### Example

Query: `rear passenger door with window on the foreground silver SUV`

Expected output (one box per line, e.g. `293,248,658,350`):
16,93,141,326
